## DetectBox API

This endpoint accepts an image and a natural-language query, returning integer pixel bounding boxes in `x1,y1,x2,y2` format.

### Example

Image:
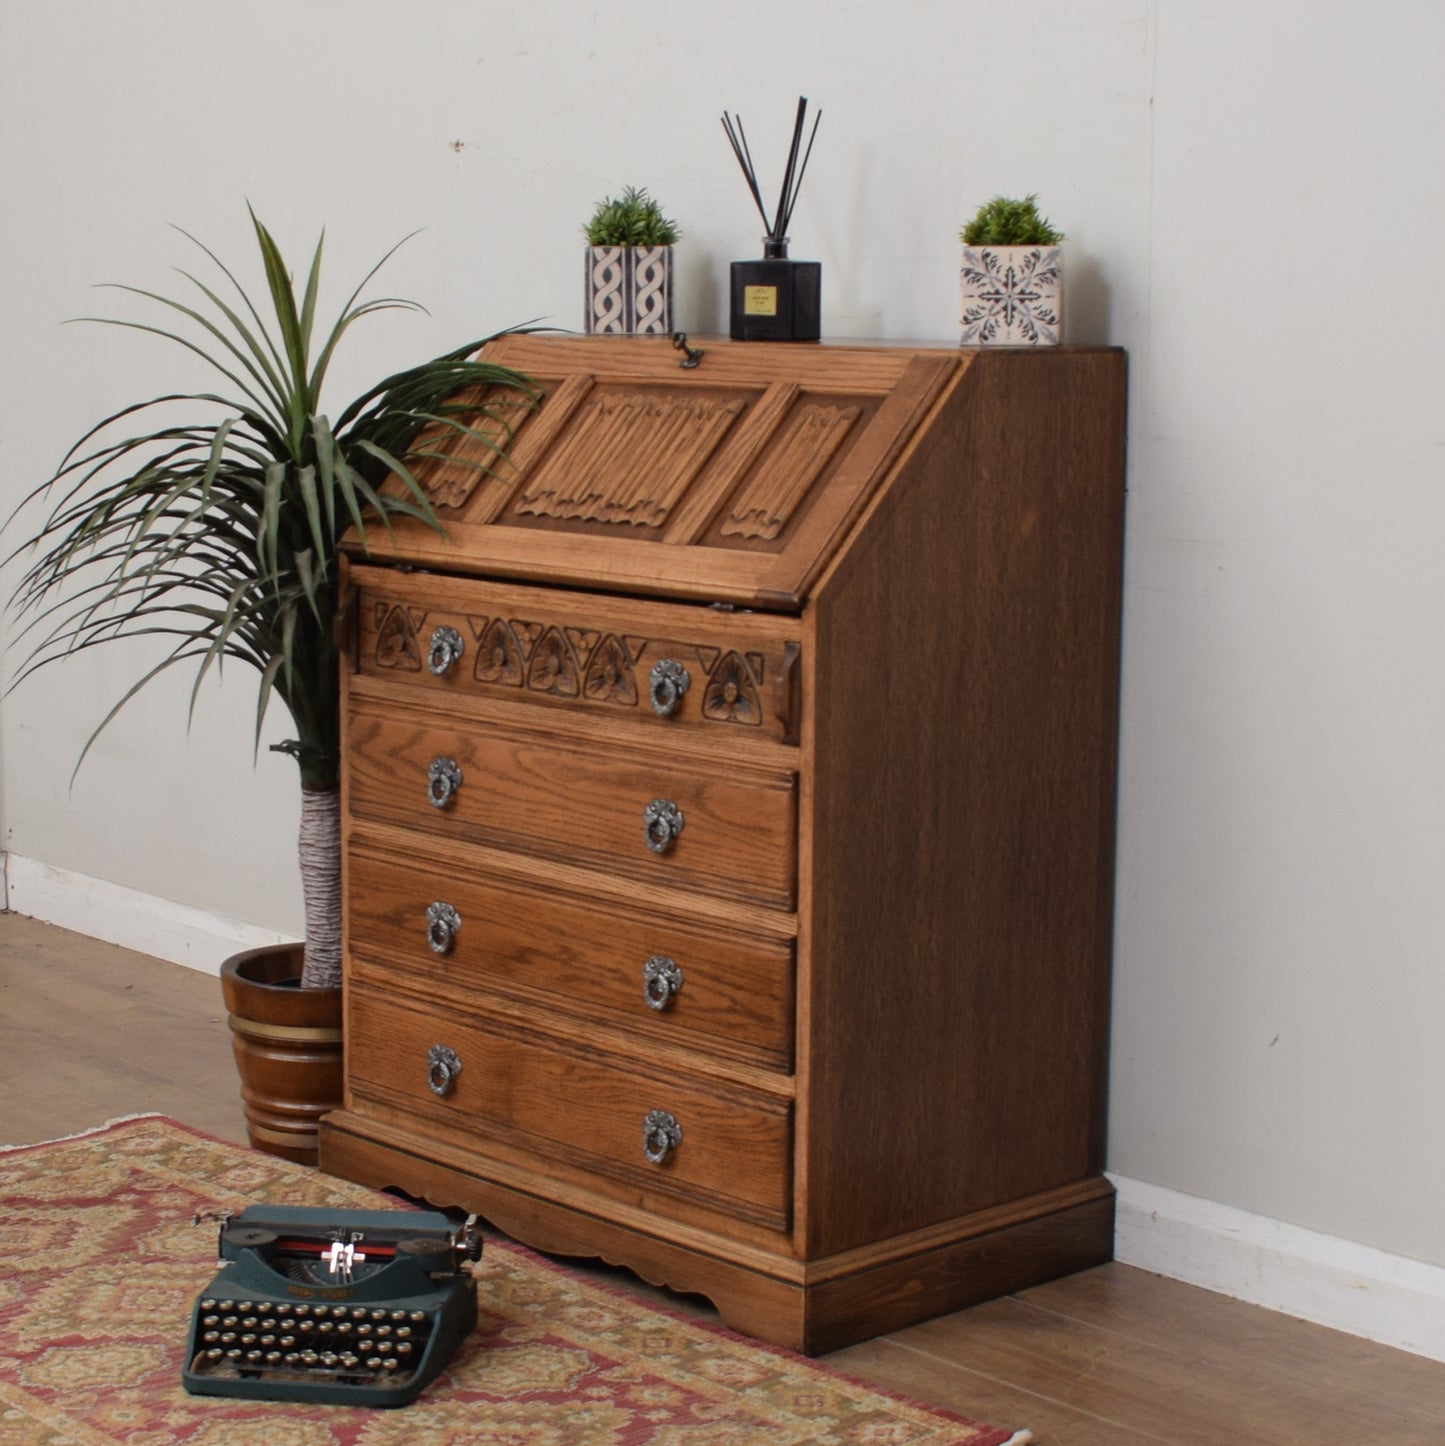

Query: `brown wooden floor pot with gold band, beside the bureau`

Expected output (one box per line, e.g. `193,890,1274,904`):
221,944,341,1165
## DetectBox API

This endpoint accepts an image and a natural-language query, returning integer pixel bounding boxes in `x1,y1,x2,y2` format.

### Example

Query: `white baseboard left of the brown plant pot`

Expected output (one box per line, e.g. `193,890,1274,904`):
3,853,294,975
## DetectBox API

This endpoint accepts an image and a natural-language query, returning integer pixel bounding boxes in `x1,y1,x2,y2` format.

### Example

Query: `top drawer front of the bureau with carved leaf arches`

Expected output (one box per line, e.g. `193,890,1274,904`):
345,568,800,740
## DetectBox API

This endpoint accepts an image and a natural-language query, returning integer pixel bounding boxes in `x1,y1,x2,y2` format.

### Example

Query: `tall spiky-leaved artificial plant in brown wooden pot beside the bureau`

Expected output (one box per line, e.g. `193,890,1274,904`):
12,213,535,1163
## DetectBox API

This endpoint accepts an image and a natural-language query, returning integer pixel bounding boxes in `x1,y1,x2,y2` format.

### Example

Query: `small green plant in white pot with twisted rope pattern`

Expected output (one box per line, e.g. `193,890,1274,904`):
583,187,681,335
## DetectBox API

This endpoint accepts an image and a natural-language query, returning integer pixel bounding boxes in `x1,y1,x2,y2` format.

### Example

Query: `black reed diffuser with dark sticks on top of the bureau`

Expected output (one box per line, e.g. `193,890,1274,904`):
723,95,823,341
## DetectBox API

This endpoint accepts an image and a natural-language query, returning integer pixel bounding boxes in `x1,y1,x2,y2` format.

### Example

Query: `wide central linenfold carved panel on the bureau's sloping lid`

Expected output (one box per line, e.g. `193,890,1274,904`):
516,392,743,528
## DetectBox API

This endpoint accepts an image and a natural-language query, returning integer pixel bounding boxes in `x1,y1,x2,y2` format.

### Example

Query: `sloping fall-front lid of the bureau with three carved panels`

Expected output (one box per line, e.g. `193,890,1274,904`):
347,334,969,610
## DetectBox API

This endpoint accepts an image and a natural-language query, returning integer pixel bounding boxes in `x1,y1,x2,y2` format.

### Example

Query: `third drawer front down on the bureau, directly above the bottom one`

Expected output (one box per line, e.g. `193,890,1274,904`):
347,842,793,1070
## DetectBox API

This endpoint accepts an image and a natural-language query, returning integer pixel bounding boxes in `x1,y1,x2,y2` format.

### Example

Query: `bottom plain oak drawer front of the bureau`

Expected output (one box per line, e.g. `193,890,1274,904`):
346,988,791,1229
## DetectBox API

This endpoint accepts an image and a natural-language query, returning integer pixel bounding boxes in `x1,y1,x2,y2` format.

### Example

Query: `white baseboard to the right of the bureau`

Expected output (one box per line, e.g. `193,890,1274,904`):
1109,1176,1445,1361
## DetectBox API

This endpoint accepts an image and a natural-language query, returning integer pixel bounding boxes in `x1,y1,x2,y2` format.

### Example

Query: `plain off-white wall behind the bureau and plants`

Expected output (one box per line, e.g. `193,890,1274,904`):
0,0,1445,1289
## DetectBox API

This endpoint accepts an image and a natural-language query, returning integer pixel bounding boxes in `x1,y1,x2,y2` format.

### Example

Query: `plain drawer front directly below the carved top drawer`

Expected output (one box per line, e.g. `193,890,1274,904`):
347,696,796,908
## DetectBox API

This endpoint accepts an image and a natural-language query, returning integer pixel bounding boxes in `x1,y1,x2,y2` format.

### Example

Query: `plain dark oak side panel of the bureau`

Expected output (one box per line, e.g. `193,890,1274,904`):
798,348,1124,1255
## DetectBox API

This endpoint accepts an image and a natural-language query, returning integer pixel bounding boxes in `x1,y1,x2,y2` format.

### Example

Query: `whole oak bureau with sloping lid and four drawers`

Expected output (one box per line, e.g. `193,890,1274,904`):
321,335,1125,1352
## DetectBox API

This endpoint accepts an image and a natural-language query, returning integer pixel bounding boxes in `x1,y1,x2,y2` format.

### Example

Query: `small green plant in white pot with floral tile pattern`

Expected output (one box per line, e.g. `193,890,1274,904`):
959,195,1063,347
